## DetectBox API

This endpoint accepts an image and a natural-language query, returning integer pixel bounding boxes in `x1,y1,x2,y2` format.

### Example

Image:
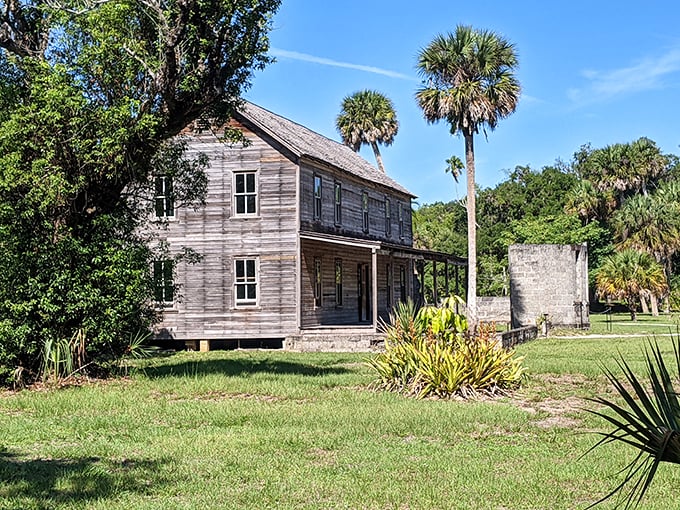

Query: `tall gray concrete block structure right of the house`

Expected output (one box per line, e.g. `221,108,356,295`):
508,244,590,328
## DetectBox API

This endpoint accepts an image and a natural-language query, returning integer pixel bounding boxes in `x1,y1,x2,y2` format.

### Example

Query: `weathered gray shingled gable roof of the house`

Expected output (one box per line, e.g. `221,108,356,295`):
236,101,415,197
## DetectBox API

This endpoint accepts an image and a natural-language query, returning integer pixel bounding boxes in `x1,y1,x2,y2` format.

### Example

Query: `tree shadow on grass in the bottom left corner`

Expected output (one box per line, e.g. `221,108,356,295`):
0,451,166,510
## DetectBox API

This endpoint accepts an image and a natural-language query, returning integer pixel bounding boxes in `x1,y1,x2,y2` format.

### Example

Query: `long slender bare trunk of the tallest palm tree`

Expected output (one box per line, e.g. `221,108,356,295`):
463,130,477,332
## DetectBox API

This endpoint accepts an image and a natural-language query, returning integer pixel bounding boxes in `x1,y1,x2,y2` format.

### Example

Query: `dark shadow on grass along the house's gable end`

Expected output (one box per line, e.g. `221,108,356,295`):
144,358,350,379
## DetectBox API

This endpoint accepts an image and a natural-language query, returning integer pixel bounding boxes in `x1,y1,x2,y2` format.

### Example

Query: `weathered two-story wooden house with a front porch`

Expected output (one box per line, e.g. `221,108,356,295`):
154,102,464,350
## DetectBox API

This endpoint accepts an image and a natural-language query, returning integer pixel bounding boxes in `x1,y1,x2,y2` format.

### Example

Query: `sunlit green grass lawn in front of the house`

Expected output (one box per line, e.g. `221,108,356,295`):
0,328,680,510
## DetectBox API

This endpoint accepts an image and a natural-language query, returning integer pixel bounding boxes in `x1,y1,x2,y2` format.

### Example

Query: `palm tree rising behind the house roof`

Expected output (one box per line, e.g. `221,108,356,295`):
335,90,399,172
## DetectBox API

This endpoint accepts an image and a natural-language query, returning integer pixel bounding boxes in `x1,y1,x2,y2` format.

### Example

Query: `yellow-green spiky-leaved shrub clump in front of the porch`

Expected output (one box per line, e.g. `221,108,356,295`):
367,297,523,398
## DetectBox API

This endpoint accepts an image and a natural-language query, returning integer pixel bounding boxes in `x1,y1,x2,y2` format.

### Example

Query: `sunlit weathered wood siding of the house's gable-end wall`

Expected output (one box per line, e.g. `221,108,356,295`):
160,122,297,339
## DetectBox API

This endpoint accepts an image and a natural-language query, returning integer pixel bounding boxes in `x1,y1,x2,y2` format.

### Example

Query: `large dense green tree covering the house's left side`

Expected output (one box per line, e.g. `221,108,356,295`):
0,0,279,381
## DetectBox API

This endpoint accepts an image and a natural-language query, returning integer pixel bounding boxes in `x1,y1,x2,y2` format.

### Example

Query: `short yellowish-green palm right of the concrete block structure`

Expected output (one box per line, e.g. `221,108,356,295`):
595,249,668,320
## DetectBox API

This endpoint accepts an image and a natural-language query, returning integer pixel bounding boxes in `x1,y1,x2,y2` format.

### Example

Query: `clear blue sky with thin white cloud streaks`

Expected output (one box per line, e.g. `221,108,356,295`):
245,0,680,204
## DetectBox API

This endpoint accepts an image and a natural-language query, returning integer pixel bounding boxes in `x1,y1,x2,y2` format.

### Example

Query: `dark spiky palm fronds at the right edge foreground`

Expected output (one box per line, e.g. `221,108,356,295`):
588,337,680,509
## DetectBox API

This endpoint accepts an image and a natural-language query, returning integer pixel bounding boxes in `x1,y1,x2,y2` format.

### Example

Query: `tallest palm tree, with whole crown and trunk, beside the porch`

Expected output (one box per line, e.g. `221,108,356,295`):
416,25,520,329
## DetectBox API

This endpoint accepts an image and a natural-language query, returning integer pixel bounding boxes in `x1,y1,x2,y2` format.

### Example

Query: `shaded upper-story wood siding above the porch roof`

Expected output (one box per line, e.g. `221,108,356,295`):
300,162,413,246
